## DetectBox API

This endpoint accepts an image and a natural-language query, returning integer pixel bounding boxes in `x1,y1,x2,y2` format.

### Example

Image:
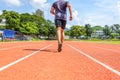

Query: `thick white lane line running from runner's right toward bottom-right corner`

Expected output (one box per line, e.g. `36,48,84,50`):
67,44,120,76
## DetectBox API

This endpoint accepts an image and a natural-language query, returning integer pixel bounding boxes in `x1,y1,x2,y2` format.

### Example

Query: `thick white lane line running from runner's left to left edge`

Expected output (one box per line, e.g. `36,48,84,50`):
0,44,53,71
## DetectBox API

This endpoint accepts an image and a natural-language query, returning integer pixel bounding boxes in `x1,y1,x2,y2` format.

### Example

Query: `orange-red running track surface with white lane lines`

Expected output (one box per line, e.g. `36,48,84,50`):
0,41,120,80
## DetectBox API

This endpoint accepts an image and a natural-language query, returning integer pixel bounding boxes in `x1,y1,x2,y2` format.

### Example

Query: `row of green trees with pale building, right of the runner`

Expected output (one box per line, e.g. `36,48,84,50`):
65,24,120,39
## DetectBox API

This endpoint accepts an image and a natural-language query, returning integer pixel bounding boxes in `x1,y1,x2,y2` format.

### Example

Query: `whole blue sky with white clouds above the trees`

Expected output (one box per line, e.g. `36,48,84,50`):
0,0,120,28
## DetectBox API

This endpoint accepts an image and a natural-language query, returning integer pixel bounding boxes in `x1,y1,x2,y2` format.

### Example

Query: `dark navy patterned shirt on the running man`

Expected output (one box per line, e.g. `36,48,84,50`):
52,1,68,20
